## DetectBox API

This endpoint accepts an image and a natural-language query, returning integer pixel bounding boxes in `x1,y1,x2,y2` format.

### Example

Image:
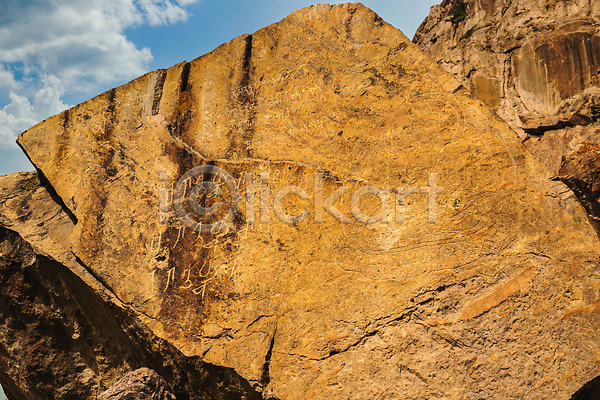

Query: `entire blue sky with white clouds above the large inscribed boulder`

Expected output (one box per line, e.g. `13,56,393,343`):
0,0,439,394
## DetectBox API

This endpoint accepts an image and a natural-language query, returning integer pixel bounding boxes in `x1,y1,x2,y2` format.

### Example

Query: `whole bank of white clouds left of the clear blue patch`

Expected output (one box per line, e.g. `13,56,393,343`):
0,0,196,148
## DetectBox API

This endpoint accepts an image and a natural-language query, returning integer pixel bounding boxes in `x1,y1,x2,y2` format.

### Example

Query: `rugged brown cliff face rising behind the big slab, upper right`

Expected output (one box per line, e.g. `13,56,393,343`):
414,0,600,233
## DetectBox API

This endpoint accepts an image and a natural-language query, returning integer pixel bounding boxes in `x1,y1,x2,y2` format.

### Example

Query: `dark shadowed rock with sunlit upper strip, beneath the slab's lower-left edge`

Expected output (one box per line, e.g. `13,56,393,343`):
0,173,260,400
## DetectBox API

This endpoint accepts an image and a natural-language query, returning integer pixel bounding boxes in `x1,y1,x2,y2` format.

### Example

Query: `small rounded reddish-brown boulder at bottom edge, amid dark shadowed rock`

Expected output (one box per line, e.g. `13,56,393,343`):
98,368,176,400
